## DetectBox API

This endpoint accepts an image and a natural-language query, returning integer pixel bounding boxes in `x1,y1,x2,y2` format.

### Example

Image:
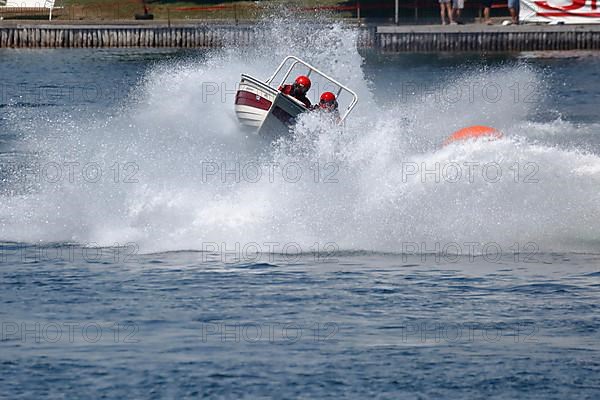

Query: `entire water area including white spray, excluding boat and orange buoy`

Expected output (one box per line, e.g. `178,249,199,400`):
0,19,600,398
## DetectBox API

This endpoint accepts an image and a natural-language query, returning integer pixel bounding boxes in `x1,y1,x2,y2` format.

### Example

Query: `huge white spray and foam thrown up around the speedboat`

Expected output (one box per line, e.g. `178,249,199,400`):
0,20,600,252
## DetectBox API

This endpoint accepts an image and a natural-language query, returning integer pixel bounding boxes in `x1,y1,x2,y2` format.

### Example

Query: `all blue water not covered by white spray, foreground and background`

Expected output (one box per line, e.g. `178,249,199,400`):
0,50,600,399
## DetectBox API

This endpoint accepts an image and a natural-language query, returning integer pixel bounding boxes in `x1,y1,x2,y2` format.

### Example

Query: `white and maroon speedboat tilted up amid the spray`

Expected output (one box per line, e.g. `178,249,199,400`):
235,56,358,137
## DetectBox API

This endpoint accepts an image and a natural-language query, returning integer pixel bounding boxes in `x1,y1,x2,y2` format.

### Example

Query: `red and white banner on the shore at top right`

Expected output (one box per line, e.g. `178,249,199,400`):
519,0,600,24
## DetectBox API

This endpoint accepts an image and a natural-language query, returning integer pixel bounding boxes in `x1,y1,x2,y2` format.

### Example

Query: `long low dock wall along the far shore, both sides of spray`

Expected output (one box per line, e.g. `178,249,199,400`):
0,23,600,52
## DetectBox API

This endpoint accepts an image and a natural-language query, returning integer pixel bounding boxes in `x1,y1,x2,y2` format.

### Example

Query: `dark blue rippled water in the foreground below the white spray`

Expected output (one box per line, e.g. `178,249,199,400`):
0,249,600,399
